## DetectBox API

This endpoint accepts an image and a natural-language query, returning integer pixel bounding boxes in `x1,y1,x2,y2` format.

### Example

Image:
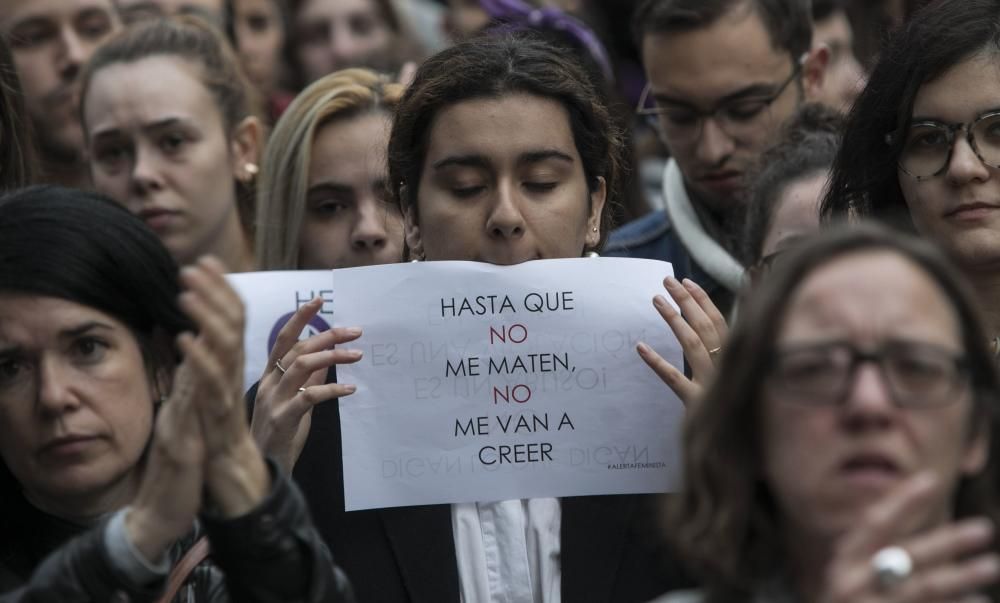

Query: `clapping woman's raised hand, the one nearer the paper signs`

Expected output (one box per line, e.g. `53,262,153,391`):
178,257,270,517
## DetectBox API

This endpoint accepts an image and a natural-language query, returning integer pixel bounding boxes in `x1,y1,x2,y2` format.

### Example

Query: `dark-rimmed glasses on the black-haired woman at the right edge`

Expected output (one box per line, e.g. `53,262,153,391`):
886,111,1000,180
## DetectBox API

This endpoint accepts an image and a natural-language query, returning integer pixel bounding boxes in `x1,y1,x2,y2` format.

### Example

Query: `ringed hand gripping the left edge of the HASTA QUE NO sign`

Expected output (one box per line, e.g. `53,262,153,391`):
250,298,361,473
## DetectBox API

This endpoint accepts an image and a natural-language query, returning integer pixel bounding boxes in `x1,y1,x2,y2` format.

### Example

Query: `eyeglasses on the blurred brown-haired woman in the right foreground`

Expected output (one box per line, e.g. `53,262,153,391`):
769,341,968,408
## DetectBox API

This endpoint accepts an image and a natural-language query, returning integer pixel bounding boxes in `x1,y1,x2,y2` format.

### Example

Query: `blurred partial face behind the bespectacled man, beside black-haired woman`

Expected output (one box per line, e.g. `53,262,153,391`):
813,11,868,113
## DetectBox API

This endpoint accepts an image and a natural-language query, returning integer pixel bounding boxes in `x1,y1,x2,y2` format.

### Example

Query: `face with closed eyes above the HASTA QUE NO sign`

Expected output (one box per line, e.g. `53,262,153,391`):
407,94,606,264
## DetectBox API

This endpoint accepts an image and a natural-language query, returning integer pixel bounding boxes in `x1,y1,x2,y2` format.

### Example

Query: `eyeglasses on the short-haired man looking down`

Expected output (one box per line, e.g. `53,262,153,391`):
636,55,807,144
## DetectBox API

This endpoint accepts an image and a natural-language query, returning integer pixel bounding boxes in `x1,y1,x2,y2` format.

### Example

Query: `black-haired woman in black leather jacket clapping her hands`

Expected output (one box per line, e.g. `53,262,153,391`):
0,187,352,603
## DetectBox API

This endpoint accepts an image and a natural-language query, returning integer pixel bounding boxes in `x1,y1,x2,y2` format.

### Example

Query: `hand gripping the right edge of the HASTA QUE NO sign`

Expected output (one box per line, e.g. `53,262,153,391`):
636,277,729,407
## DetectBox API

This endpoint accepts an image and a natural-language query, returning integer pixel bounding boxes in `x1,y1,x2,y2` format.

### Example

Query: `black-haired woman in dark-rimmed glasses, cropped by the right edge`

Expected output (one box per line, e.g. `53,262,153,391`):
824,0,1000,349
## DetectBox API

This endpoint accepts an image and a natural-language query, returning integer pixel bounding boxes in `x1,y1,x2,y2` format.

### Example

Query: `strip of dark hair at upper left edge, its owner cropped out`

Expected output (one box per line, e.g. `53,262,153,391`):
0,37,35,192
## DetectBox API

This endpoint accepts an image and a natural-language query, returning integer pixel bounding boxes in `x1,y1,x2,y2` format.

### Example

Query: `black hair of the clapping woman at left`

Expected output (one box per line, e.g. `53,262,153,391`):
0,186,194,542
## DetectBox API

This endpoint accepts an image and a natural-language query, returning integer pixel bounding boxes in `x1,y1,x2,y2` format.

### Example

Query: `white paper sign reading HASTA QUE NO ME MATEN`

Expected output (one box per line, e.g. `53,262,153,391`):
331,258,684,510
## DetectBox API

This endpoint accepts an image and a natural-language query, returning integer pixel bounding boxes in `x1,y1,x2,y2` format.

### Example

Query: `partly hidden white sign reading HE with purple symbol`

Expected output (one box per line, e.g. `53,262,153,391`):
226,270,333,391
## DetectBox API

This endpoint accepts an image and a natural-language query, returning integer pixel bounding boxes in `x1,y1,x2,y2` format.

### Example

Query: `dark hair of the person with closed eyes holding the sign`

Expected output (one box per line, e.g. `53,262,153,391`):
388,32,624,248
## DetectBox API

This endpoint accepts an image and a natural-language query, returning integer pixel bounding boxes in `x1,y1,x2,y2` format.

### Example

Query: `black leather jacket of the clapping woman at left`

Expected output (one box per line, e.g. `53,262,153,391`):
0,463,354,603
